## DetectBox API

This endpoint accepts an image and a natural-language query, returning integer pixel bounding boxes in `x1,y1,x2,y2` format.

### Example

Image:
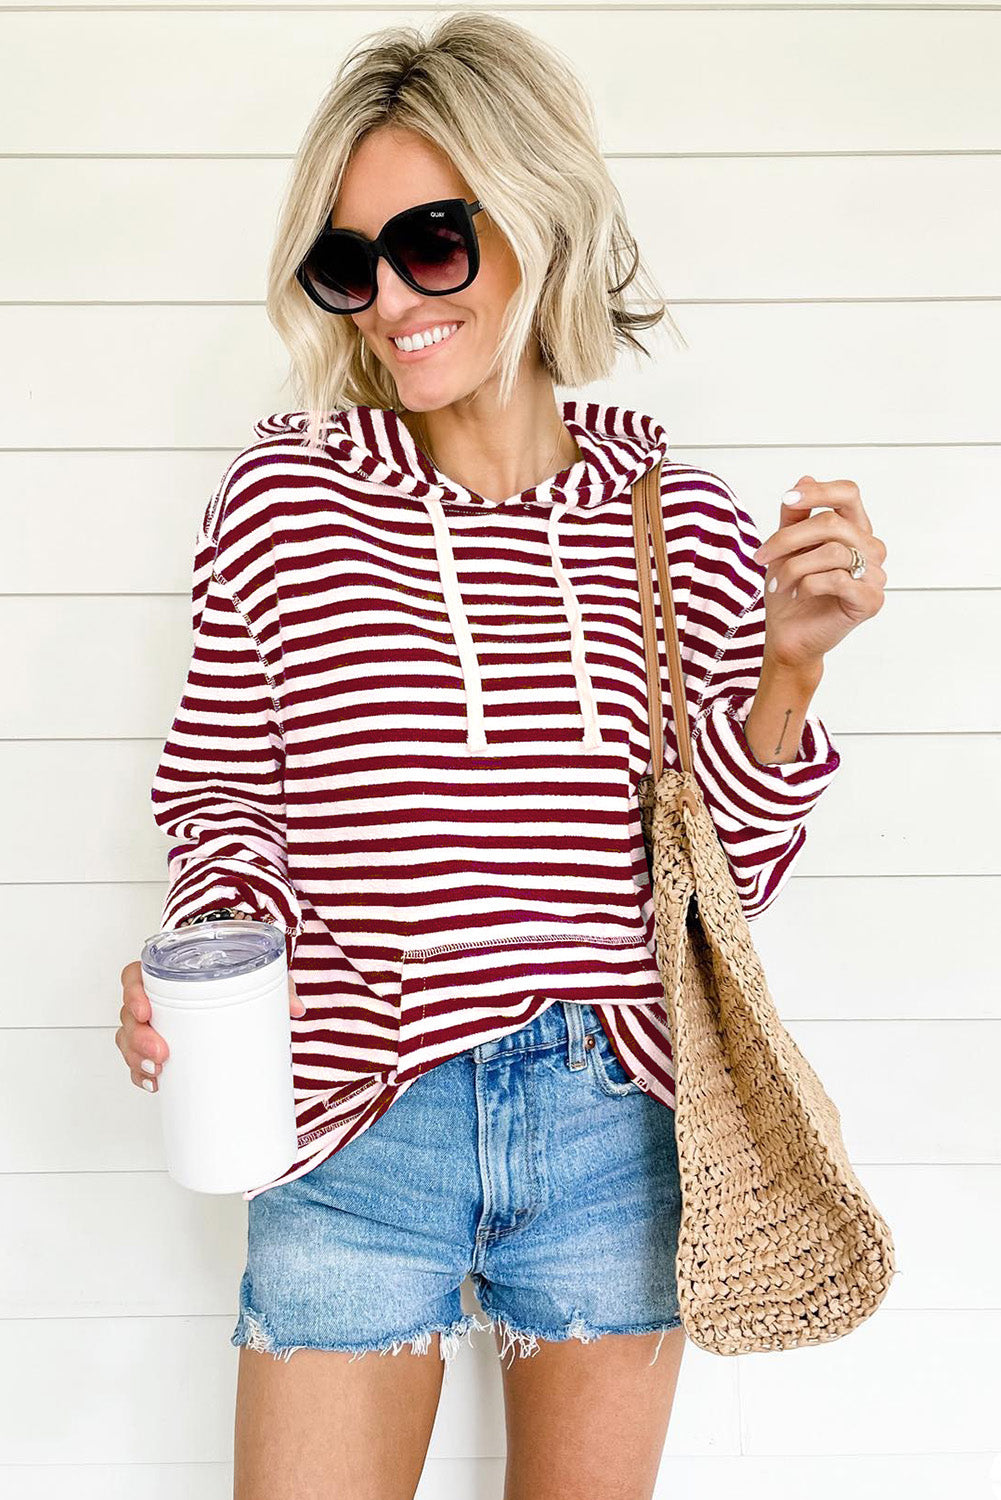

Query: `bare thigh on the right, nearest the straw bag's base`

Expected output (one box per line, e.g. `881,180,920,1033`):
495,1328,684,1500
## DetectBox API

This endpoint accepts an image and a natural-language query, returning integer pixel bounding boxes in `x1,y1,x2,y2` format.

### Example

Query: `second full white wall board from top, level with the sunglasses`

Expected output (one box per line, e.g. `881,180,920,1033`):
0,155,1001,303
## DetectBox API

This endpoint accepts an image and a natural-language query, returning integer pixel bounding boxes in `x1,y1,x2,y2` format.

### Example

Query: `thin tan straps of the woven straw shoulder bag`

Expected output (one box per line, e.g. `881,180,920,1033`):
632,462,692,782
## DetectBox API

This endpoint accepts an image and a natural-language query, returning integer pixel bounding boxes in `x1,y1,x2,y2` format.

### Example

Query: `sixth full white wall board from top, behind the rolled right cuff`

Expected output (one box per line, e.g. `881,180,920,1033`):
0,732,1001,885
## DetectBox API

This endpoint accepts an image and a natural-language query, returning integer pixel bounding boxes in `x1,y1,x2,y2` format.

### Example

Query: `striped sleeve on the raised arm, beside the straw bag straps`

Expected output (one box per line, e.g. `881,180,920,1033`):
669,476,840,920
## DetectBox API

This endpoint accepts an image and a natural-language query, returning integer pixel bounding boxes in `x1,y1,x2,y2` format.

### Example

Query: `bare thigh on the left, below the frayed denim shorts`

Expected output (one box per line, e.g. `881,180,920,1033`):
233,1334,444,1500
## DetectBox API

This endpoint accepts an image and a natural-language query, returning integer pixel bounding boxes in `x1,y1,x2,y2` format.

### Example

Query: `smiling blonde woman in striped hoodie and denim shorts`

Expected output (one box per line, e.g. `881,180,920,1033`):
117,12,885,1500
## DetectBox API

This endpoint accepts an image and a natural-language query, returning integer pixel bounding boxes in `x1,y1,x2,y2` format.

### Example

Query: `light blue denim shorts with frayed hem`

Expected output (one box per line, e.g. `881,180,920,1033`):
230,1001,681,1373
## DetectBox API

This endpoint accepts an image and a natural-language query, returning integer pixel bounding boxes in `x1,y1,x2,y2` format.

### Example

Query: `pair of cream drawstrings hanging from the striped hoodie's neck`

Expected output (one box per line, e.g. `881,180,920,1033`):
422,495,605,752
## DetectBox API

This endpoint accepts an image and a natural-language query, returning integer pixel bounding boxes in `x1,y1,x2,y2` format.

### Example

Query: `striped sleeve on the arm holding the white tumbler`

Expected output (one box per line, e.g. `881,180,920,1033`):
150,497,302,965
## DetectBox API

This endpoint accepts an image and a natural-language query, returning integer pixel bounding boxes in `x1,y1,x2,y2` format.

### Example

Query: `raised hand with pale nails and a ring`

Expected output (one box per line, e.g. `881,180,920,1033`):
753,474,887,668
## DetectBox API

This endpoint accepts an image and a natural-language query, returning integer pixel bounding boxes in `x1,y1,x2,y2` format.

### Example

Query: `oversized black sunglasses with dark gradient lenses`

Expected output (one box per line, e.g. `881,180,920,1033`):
296,198,483,312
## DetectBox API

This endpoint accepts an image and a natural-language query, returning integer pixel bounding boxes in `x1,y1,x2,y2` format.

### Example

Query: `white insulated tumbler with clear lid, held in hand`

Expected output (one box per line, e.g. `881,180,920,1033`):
140,920,299,1193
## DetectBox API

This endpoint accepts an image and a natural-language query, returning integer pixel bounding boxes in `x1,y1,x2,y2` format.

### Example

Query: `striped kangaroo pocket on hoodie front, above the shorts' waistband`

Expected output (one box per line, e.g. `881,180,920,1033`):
396,930,663,1080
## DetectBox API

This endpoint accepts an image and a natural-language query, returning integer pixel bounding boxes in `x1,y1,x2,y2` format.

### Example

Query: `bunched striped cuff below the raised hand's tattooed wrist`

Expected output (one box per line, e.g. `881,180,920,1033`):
692,693,840,830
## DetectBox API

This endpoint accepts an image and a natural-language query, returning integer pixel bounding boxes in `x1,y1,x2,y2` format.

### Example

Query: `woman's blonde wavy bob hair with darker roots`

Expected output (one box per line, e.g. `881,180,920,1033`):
266,11,686,447
